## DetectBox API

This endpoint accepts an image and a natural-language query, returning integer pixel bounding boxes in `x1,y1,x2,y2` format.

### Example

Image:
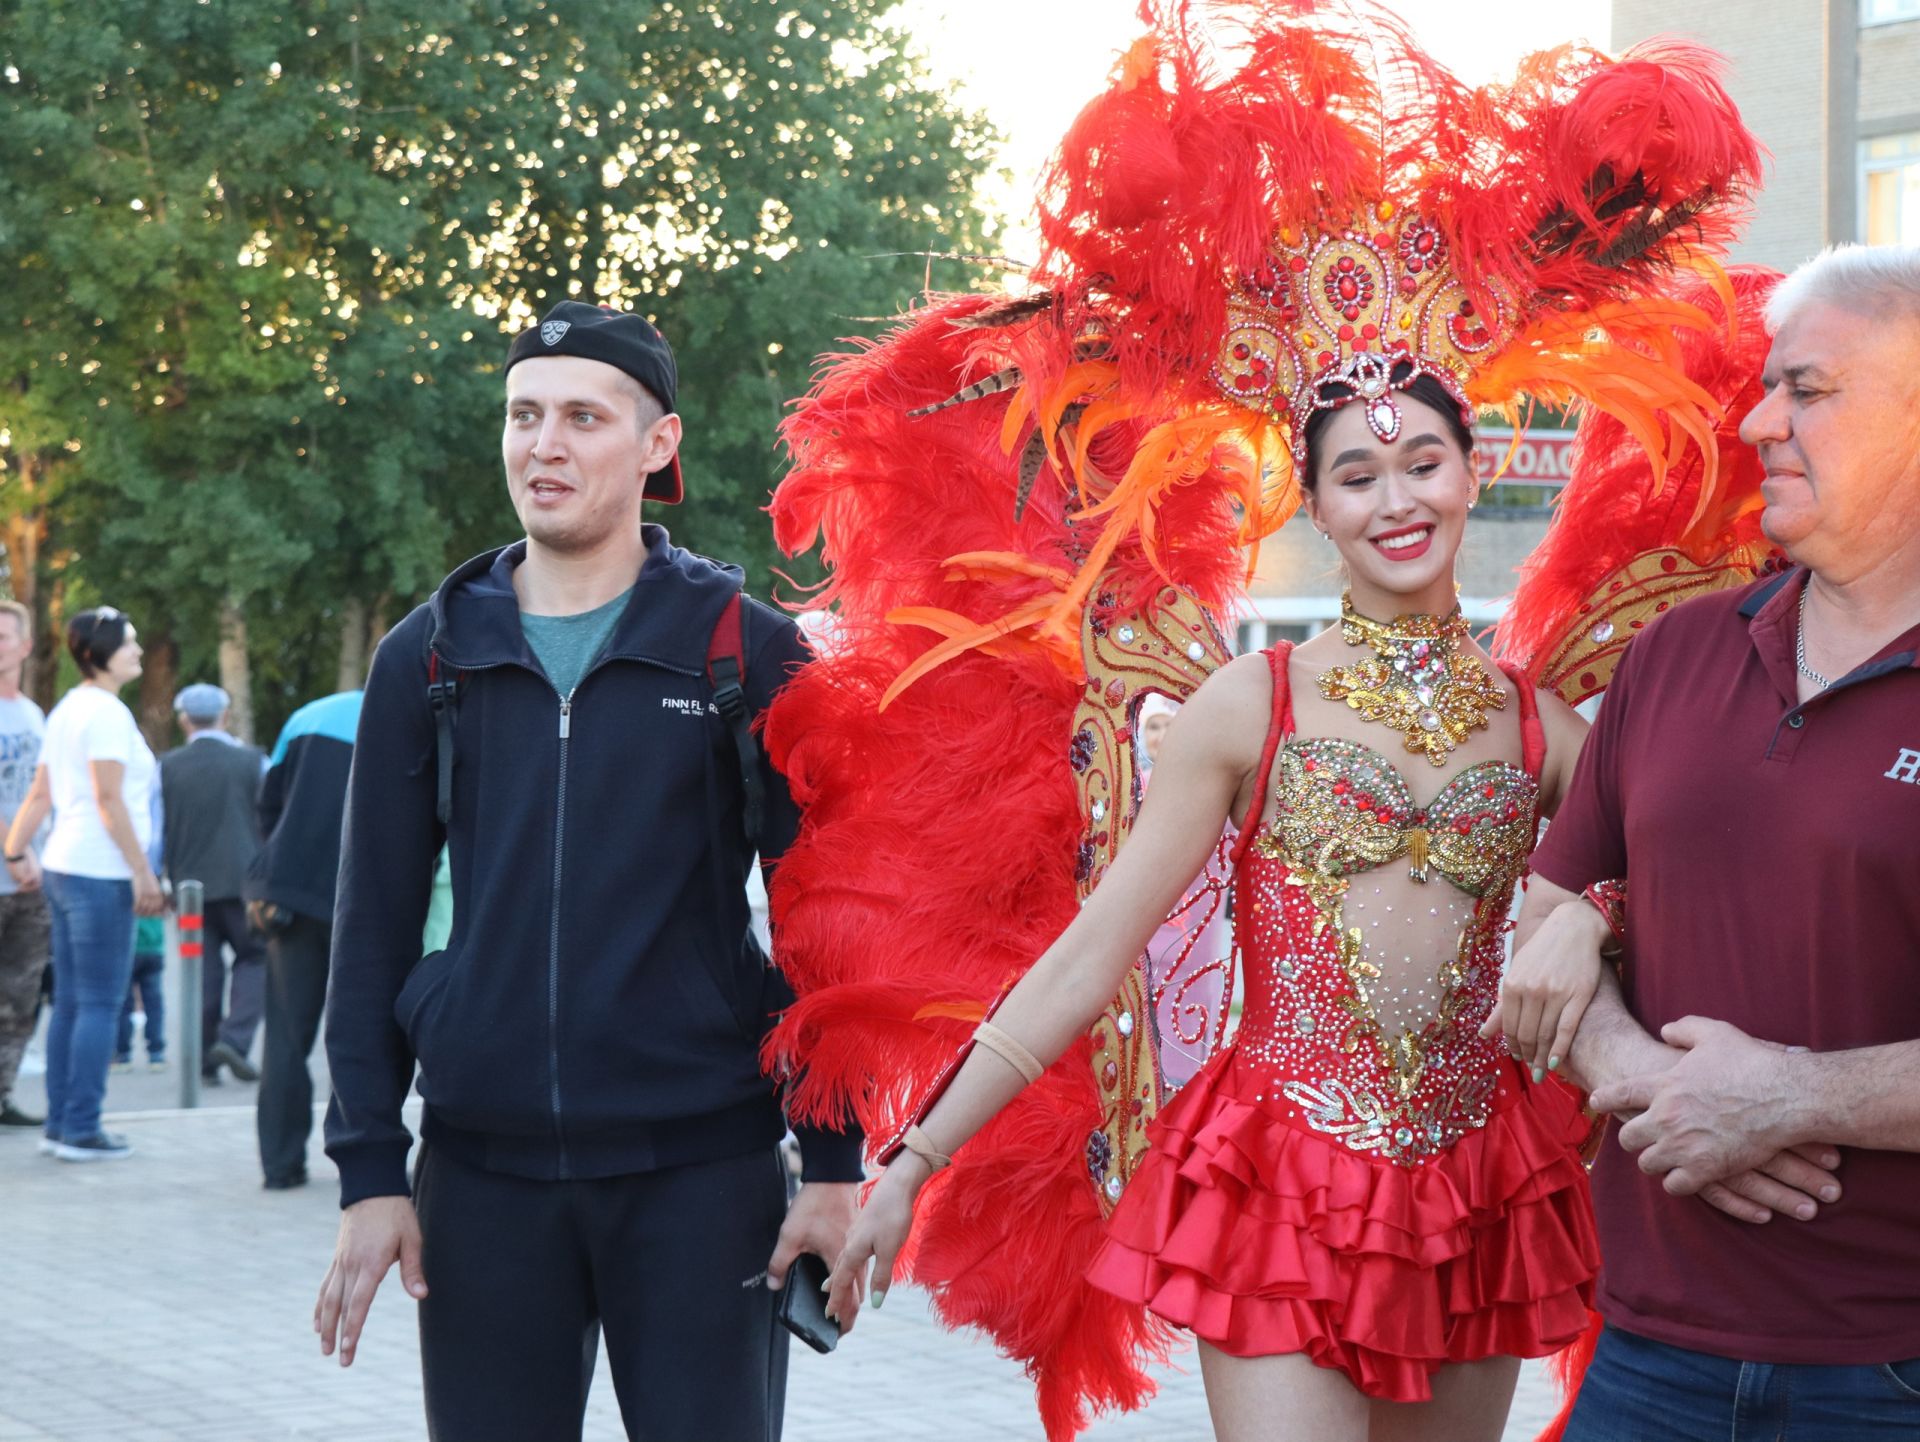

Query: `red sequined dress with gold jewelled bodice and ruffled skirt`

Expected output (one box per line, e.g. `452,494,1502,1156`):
1091,645,1599,1402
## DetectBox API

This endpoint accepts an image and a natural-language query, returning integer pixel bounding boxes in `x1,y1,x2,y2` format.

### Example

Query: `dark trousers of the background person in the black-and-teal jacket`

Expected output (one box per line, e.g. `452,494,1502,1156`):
255,912,334,1181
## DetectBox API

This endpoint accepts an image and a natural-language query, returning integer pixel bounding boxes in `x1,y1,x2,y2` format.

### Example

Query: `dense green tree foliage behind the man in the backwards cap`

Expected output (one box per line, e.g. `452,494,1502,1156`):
0,0,987,733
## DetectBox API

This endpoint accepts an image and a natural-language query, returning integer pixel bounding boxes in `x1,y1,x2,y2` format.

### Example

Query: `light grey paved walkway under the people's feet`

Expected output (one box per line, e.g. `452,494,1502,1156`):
0,1075,1549,1442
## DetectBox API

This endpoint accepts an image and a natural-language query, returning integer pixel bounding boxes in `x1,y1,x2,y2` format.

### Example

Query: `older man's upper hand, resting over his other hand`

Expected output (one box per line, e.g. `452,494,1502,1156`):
1592,1016,1812,1200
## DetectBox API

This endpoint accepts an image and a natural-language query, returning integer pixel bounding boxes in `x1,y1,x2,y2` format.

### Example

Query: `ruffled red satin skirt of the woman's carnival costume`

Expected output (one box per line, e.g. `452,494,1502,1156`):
1089,1052,1599,1402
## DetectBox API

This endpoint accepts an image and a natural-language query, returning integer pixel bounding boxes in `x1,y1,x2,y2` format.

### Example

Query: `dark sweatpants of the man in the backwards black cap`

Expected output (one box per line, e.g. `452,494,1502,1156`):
413,1142,787,1442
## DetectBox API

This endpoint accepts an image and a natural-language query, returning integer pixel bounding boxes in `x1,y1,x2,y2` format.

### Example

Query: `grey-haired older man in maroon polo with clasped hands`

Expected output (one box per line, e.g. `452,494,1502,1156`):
1521,246,1920,1442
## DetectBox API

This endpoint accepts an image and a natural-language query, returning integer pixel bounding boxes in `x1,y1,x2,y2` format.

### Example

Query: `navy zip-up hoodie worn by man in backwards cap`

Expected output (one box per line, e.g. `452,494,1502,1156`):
326,526,860,1206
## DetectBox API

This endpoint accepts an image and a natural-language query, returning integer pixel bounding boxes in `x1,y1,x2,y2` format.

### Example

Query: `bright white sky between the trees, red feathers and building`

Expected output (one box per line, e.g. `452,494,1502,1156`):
897,0,1613,259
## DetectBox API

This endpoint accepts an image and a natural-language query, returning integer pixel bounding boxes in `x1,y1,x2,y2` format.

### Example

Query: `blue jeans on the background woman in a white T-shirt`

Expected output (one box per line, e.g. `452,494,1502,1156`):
44,872,132,1141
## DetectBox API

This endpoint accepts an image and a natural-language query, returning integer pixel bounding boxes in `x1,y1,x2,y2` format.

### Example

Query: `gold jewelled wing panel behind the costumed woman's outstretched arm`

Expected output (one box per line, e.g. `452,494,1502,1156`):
1068,588,1233,1212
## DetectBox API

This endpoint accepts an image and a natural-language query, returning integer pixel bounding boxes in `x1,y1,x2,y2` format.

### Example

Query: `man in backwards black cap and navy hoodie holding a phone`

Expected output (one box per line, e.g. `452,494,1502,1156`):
315,301,860,1442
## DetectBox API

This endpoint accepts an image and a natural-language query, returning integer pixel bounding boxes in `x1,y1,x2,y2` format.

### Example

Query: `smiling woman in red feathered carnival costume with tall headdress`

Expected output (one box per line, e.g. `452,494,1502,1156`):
768,0,1757,1442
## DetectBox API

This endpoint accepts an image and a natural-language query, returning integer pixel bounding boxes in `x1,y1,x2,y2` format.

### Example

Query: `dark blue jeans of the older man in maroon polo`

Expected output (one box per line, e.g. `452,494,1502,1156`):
1565,1327,1920,1442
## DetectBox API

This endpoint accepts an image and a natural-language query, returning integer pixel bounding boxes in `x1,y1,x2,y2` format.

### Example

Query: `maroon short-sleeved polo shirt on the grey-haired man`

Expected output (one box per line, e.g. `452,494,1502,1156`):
1532,570,1920,1363
